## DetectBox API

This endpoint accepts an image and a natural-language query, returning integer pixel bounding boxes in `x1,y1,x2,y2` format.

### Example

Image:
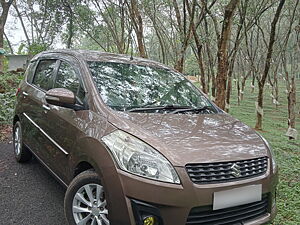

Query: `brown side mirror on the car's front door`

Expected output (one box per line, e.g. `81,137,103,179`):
45,88,76,108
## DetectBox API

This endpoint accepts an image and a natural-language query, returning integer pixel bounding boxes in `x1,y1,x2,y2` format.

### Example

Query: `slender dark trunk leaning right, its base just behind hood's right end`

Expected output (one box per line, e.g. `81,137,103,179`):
255,0,285,130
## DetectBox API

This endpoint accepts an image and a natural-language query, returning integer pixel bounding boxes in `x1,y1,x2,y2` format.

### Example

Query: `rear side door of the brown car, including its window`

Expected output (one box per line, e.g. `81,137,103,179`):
21,59,57,163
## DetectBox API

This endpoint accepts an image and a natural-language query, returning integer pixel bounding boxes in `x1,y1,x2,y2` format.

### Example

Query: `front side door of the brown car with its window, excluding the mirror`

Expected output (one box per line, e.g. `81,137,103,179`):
39,59,85,181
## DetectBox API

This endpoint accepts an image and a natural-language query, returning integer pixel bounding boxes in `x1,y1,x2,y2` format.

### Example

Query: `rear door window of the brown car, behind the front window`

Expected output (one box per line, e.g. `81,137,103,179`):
32,59,56,91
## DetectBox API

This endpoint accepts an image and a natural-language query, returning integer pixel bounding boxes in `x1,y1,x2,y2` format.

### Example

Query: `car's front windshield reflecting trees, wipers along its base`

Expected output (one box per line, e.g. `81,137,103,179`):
88,61,216,113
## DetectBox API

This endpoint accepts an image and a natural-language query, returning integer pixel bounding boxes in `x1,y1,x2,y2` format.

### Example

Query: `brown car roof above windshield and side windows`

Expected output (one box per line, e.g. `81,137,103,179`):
33,49,174,70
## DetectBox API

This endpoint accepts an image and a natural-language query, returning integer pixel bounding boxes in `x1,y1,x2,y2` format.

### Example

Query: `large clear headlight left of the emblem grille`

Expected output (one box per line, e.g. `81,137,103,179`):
102,130,180,184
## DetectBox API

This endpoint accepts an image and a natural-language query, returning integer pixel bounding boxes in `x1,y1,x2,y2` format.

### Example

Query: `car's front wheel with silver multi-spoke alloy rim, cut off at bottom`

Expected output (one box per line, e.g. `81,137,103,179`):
64,170,110,225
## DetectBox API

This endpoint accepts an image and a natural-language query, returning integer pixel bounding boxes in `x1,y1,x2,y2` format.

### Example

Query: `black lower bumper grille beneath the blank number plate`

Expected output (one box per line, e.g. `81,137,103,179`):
186,195,268,225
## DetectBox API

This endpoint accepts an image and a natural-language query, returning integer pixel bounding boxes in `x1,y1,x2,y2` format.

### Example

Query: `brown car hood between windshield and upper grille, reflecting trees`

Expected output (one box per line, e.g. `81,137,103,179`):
108,111,268,166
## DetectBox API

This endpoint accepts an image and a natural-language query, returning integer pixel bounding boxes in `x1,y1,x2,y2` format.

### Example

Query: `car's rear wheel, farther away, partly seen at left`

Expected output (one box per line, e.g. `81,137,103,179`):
13,121,32,163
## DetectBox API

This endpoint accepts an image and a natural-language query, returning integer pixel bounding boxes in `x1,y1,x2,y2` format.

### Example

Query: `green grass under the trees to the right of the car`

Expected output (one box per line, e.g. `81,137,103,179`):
230,80,300,225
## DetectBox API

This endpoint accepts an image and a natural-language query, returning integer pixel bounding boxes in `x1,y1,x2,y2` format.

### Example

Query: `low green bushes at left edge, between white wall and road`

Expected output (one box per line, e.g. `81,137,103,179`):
0,73,23,124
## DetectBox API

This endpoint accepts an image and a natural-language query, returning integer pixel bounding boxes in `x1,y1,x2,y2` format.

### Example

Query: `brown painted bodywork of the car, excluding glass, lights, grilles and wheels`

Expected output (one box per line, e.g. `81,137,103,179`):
14,50,278,225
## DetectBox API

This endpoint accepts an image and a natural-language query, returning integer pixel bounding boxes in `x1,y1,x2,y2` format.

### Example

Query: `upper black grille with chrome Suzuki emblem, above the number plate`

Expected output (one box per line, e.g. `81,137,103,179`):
185,157,268,184
